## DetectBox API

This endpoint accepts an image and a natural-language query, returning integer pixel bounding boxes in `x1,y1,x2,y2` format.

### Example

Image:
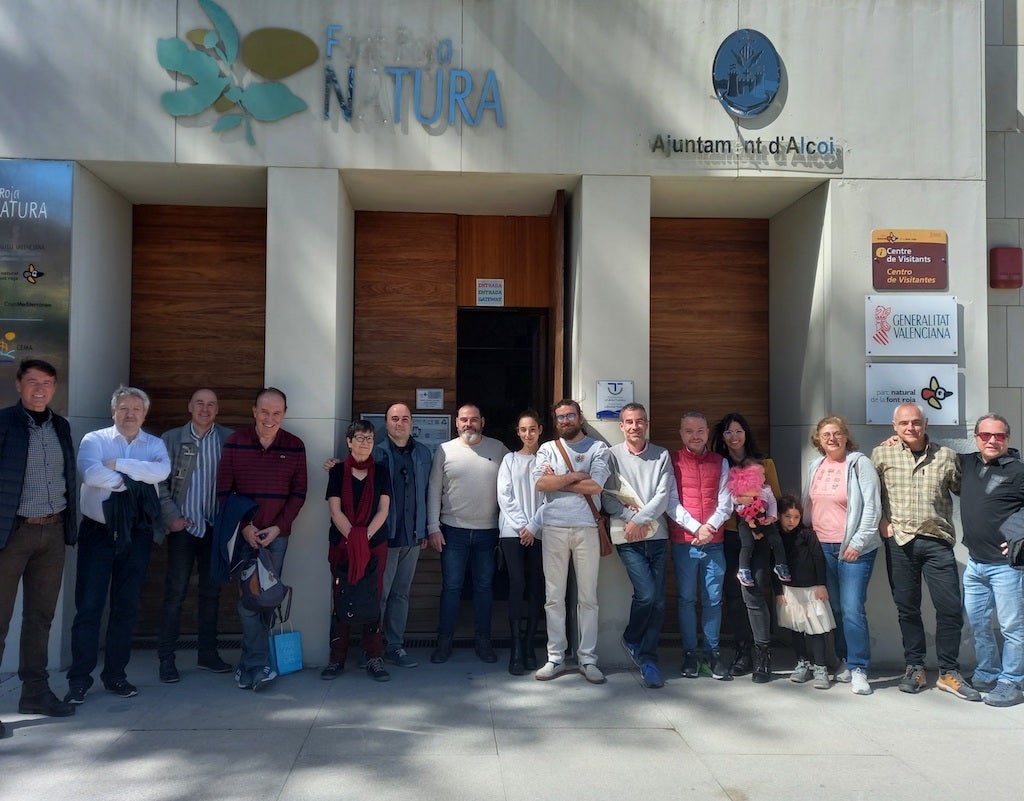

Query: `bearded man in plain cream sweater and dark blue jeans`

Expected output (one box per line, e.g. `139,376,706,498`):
427,404,508,664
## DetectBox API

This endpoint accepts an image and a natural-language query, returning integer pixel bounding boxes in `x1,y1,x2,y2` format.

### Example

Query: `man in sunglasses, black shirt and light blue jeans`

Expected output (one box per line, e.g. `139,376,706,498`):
961,414,1024,707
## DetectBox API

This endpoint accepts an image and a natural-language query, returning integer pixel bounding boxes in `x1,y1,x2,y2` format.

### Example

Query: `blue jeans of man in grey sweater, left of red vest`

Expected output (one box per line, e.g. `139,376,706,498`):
615,540,669,665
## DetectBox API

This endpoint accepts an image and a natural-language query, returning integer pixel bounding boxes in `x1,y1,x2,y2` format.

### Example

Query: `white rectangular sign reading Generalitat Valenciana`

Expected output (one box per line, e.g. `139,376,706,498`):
864,292,959,356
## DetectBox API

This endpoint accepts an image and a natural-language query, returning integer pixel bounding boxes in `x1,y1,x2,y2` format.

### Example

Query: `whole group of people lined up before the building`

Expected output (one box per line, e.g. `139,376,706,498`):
0,360,1024,741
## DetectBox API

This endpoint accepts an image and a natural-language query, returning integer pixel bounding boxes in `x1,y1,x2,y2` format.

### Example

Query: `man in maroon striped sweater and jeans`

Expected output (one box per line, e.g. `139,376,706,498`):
217,387,306,690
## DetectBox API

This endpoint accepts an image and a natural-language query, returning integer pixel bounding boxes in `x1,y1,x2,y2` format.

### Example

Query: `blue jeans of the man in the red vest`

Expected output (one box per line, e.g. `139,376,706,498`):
672,542,725,650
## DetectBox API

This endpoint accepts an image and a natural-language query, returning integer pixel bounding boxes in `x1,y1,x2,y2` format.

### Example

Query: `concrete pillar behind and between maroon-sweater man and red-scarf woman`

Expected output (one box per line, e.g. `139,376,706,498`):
265,168,355,665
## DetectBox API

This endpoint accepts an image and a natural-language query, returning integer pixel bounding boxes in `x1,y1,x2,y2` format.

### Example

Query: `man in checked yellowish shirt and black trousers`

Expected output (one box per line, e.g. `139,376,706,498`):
871,404,981,701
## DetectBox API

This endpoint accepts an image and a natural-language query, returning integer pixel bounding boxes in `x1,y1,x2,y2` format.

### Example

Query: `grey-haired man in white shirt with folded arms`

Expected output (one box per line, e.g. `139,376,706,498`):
65,386,171,704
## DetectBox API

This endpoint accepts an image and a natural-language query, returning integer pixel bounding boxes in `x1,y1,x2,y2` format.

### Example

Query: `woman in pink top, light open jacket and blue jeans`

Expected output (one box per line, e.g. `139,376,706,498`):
804,415,882,695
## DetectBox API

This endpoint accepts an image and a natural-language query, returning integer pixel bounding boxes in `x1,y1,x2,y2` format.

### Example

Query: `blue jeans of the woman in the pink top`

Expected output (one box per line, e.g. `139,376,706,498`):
821,542,879,670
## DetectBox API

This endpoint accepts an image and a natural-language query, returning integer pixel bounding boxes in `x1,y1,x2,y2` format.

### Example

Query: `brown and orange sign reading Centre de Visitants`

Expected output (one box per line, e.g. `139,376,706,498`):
871,228,949,292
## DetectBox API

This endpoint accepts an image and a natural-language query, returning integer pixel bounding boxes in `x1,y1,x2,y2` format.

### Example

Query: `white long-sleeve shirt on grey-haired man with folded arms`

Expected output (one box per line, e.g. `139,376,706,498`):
78,425,171,522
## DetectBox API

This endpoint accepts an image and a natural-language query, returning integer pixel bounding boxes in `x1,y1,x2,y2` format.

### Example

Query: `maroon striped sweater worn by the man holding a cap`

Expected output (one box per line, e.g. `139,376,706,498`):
217,425,306,537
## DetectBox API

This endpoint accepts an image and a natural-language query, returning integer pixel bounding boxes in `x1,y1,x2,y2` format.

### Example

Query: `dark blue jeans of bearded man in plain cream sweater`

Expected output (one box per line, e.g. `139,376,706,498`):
437,524,498,637
